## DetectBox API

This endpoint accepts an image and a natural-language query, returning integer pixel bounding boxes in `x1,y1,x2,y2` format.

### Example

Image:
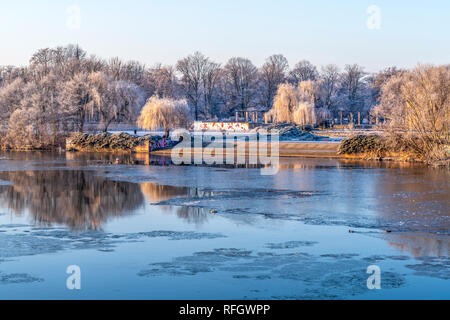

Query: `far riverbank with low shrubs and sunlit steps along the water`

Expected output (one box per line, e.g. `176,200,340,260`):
2,128,450,167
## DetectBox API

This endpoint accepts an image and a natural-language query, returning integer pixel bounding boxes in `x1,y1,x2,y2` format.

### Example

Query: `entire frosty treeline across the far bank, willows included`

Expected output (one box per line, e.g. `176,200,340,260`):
0,45,450,159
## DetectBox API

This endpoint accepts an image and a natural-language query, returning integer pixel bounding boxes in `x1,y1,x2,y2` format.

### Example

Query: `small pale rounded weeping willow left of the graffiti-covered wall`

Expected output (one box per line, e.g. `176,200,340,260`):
137,96,190,138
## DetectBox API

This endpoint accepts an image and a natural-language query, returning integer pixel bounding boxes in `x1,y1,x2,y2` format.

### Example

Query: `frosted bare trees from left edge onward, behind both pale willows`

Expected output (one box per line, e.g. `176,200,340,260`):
0,45,388,147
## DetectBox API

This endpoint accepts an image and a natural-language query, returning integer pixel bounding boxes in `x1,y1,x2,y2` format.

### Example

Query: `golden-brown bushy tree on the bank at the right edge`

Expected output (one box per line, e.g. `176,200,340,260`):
377,65,450,160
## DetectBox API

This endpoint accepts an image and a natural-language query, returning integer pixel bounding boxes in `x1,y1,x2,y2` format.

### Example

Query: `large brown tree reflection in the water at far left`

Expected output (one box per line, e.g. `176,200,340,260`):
0,170,144,230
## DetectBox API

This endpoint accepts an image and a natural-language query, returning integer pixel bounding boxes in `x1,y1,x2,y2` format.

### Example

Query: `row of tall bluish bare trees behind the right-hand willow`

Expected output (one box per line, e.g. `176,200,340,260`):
175,52,384,119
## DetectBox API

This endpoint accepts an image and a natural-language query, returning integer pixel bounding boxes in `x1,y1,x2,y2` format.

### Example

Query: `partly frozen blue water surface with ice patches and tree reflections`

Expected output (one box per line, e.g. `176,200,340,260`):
0,153,450,299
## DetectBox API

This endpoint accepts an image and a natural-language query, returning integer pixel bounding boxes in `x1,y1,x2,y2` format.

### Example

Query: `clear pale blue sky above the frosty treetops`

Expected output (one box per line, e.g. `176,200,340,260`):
0,0,450,71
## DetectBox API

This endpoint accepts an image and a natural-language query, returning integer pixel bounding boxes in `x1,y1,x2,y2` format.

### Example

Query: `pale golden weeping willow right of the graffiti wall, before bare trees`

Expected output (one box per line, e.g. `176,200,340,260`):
266,81,317,125
